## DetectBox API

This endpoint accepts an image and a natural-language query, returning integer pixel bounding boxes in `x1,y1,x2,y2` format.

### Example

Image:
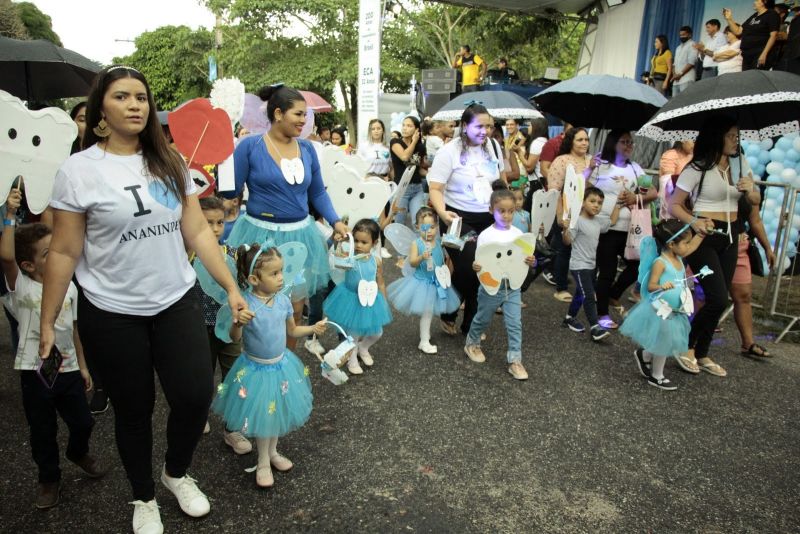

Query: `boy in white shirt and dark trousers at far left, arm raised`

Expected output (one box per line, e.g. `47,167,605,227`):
0,189,105,509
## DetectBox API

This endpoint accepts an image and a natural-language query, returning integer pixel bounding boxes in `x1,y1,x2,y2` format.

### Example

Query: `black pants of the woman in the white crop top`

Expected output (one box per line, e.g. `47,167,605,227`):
686,221,739,358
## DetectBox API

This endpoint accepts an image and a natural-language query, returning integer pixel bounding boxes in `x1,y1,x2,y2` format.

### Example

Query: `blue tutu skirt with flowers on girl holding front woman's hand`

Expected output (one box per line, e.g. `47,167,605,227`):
211,349,314,438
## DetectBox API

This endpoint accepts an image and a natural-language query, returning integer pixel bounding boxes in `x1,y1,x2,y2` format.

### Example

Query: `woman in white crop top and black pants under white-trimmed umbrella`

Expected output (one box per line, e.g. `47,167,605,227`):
670,116,761,376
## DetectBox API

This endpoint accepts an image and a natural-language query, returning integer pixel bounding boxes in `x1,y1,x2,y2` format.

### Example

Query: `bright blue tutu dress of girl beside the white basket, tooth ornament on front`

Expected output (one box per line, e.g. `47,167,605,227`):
322,254,392,336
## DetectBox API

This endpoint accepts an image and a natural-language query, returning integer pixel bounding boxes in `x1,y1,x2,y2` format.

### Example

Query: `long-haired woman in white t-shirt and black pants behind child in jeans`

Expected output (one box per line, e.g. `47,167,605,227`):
428,104,504,334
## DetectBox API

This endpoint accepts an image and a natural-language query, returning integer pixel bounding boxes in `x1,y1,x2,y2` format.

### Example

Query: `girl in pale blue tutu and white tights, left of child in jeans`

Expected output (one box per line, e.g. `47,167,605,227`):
388,207,461,354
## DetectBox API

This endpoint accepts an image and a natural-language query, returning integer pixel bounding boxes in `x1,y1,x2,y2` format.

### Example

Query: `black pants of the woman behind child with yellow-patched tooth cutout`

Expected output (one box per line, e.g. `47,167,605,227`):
439,206,494,334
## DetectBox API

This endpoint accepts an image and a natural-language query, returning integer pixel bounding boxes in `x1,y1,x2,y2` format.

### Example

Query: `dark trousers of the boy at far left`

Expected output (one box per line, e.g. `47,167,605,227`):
19,371,94,483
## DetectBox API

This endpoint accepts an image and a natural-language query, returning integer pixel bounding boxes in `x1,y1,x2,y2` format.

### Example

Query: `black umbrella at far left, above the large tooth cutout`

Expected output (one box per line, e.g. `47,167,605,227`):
0,37,101,101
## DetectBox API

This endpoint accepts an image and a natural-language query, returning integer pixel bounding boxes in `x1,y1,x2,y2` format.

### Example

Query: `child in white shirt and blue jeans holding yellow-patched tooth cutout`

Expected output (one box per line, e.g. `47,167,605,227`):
464,181,536,380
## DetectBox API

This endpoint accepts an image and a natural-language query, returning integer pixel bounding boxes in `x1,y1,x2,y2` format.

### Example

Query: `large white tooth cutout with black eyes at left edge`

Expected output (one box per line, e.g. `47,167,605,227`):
0,91,78,214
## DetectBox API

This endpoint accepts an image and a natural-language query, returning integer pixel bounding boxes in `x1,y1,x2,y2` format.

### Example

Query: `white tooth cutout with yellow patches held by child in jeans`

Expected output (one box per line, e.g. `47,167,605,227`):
475,233,536,295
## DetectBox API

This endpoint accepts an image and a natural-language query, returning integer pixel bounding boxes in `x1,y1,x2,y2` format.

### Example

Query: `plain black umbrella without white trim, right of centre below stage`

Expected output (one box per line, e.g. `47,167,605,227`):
533,74,667,130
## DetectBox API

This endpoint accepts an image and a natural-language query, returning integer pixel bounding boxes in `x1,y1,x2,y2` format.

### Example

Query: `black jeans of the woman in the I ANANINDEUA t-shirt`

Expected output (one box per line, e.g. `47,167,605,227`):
78,292,213,501
